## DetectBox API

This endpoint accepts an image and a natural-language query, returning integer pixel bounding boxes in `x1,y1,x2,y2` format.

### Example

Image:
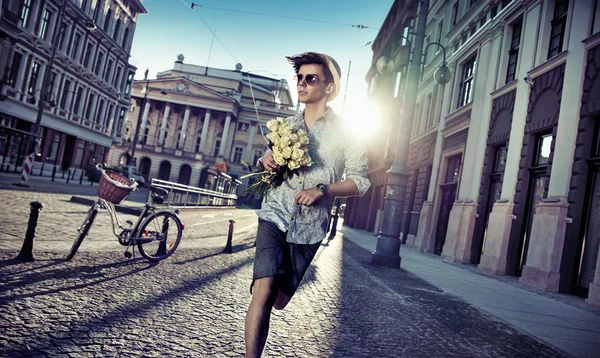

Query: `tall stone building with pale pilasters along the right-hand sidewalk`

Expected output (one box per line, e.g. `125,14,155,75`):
347,0,600,305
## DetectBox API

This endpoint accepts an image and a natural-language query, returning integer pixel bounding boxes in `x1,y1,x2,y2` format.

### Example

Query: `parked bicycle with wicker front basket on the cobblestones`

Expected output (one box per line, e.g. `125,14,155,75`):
67,164,185,261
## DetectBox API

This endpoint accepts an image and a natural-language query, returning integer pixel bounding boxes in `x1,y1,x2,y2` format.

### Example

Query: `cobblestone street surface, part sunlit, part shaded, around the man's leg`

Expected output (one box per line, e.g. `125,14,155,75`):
0,236,564,357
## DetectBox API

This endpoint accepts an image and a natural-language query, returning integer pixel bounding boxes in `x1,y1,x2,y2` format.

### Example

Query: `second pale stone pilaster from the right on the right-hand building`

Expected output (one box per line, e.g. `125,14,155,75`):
478,3,544,275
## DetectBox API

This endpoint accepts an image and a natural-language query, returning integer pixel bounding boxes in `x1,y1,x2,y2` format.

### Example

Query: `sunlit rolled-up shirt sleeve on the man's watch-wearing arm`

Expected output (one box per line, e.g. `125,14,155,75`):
344,136,371,196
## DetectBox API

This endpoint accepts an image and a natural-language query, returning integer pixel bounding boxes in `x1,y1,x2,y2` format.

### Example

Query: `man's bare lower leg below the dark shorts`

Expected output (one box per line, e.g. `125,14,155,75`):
245,277,279,358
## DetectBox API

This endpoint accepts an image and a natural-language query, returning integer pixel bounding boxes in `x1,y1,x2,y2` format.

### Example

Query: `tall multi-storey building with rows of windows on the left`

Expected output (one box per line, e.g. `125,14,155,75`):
0,0,146,171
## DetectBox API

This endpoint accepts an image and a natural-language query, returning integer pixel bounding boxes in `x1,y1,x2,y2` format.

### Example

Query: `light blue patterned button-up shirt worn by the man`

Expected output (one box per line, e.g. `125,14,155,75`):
258,108,371,244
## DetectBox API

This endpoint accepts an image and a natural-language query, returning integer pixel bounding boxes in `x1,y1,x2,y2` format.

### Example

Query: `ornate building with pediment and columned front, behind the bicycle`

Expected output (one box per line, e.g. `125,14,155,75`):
108,55,296,196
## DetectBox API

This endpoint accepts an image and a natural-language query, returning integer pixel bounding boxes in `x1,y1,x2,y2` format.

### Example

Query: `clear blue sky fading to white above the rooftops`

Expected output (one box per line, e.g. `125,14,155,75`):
130,0,393,123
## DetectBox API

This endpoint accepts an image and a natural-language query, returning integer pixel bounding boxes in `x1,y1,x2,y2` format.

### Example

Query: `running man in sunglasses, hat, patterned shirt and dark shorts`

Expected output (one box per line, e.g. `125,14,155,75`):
245,52,370,357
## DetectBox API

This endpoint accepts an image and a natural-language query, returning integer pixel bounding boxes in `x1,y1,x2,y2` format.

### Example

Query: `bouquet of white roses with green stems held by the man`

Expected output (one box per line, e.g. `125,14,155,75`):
241,118,312,196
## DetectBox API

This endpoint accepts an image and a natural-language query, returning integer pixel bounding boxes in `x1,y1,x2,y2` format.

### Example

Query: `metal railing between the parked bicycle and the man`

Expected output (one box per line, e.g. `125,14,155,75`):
148,178,239,208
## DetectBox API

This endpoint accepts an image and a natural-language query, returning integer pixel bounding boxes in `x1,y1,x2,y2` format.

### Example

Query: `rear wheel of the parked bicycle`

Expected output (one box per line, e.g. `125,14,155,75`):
135,211,183,261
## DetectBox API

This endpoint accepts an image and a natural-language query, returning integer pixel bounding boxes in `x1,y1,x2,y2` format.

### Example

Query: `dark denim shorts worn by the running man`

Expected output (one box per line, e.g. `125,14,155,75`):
250,219,321,297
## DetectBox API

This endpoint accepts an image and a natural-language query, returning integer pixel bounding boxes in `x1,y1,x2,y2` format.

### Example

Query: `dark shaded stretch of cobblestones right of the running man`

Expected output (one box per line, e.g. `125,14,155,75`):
333,240,564,358
